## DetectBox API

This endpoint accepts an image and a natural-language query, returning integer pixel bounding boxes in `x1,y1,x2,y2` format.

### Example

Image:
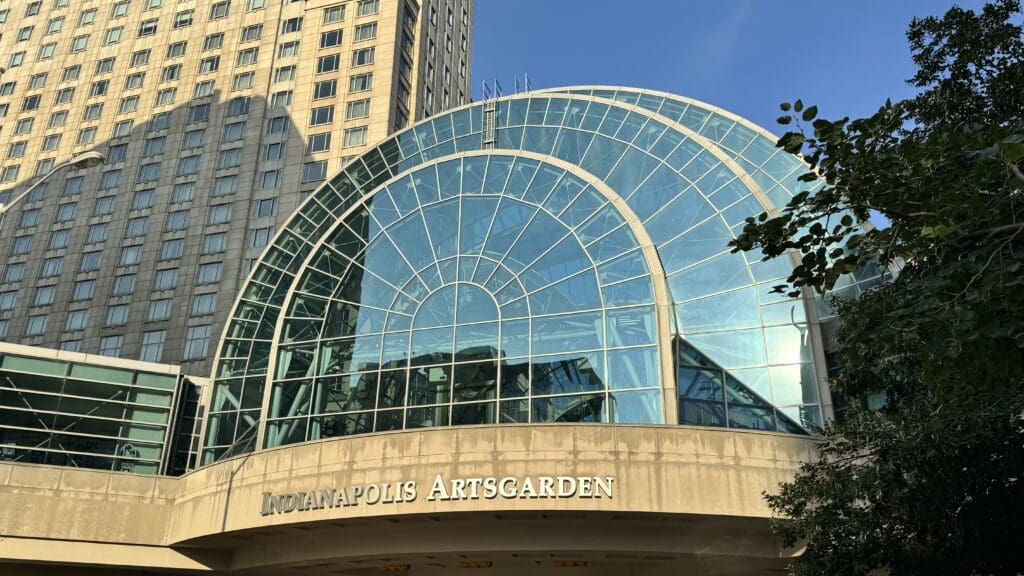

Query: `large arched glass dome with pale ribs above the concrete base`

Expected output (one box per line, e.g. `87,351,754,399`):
203,88,864,462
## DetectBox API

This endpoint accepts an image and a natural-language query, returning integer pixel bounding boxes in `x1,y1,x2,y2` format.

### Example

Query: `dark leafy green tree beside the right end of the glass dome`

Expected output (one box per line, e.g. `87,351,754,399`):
732,0,1024,576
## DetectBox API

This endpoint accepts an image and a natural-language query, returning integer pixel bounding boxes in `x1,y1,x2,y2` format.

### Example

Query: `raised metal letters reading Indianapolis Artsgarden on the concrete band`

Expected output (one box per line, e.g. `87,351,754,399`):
260,475,615,516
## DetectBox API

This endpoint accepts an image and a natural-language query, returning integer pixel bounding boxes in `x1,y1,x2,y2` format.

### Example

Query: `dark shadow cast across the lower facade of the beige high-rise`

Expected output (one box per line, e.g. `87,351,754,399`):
0,91,307,366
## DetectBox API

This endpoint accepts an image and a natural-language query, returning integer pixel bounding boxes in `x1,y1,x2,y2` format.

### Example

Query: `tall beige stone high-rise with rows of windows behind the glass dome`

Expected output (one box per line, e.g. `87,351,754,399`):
0,0,473,375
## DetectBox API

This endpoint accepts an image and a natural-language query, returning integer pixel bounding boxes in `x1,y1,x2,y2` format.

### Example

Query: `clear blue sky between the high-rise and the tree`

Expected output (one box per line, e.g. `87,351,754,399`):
473,0,982,133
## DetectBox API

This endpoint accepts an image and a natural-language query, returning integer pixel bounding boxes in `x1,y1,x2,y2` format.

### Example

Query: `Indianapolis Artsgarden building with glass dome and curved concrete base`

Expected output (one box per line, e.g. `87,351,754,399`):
0,86,879,576
